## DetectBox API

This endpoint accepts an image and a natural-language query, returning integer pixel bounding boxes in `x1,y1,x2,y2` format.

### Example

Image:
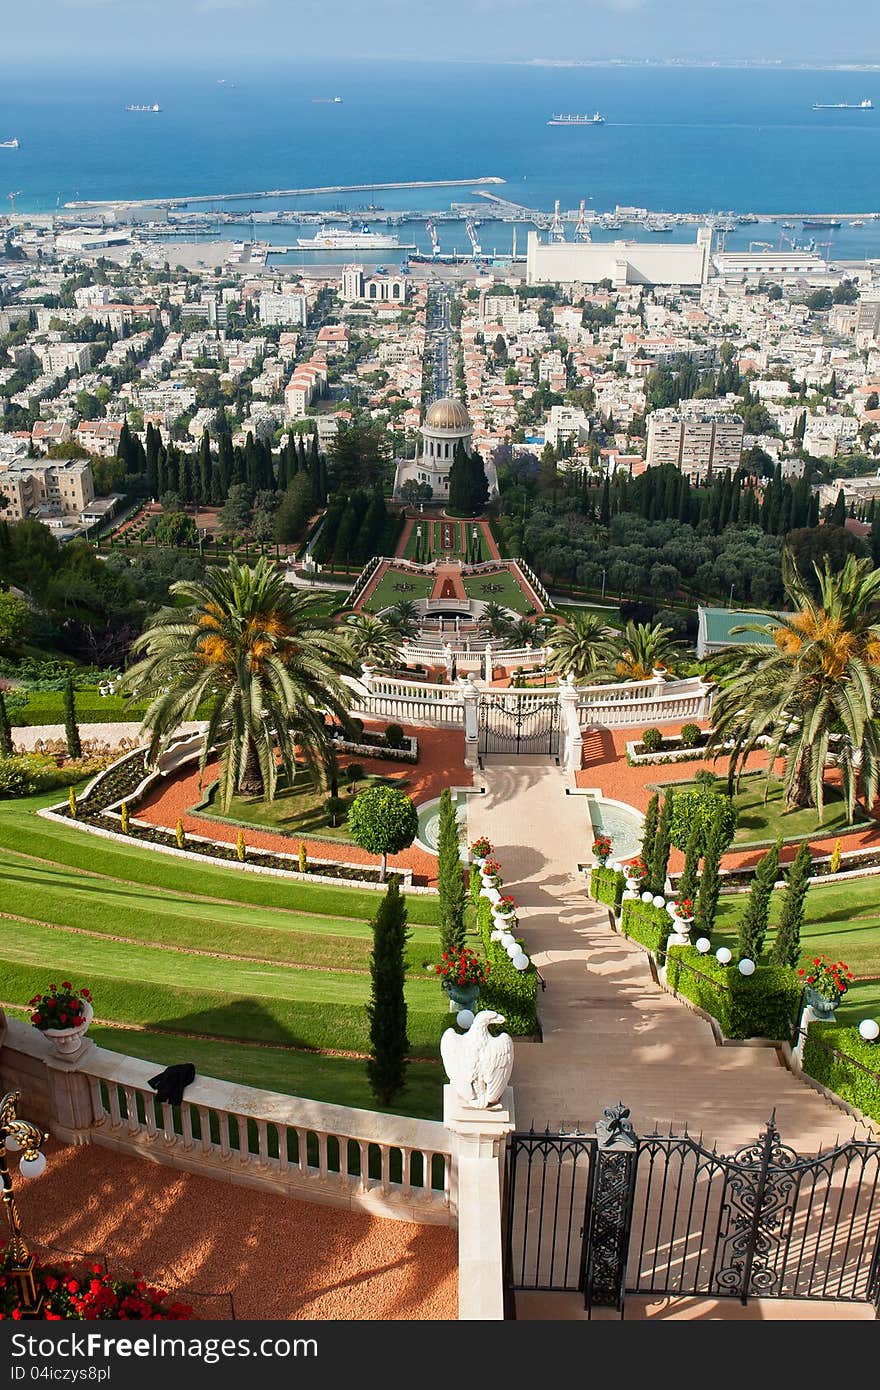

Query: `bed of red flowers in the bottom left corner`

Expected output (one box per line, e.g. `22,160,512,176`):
0,1243,192,1322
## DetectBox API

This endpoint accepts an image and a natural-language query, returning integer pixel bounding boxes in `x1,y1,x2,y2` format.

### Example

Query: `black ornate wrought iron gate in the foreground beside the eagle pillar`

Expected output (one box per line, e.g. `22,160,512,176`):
506,1105,880,1316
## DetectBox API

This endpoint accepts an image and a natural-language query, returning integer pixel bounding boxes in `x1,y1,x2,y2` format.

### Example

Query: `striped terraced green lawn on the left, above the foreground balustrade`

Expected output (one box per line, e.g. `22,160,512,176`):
0,792,448,1116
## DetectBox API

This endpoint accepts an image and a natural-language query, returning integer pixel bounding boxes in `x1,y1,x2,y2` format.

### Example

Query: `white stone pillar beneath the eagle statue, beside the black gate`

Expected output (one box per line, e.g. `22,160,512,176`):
443,1086,514,1322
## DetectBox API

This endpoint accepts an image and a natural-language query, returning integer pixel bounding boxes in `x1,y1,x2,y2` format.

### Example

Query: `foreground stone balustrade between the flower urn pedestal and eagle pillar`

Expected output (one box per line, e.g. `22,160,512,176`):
78,1048,455,1225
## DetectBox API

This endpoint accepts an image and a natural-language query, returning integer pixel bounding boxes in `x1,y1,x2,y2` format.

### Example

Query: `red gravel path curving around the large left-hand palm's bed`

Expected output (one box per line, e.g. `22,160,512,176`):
136,721,474,887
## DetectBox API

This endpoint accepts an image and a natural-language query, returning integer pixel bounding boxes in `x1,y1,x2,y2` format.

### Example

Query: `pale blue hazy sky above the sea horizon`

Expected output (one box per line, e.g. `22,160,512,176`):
0,0,880,70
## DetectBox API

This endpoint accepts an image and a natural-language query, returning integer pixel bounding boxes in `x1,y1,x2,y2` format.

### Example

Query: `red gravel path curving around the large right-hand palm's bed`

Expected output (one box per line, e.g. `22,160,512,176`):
576,724,880,873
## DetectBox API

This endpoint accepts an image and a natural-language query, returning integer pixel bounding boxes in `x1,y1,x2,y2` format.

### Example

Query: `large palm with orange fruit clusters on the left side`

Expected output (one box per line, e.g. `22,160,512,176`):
124,557,357,810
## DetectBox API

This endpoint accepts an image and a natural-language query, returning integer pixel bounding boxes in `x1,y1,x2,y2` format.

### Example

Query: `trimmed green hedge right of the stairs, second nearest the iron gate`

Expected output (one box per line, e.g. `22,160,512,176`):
666,947,804,1040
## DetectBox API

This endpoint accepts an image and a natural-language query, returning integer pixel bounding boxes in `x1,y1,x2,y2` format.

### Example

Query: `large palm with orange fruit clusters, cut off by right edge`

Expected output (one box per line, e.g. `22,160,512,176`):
708,552,880,823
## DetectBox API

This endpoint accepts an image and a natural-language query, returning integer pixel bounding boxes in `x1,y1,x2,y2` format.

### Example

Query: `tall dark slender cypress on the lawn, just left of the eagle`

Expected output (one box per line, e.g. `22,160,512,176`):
367,876,410,1105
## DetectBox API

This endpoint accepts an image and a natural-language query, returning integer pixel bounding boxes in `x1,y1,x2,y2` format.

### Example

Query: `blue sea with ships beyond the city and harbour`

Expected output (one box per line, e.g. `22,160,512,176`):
0,60,880,264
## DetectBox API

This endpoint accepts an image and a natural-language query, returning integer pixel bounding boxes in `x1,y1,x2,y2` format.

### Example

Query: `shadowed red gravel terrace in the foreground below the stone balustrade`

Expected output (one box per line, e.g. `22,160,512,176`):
15,1144,457,1321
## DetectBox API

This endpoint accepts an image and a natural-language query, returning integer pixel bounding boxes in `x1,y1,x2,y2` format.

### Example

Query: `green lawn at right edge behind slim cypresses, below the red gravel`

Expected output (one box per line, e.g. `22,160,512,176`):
712,877,880,1024
